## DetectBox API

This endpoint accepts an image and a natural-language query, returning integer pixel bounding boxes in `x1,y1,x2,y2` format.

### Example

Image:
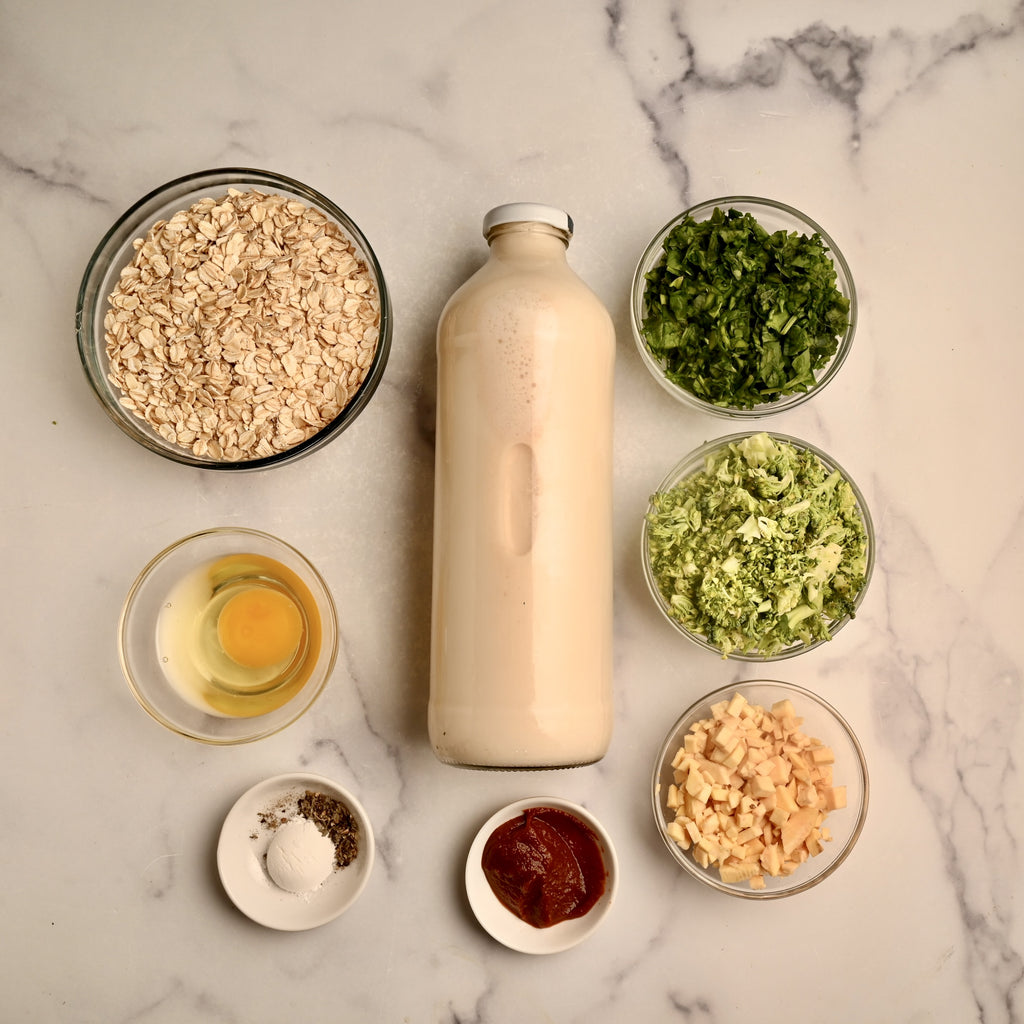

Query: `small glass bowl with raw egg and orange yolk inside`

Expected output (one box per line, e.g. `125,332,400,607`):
118,527,338,744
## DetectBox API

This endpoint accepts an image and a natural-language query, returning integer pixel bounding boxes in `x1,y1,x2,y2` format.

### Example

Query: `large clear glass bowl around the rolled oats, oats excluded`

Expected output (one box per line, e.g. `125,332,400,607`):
75,167,393,472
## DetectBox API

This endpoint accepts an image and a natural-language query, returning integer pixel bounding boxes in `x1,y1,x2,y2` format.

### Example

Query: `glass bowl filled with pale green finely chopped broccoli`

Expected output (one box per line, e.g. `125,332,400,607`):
642,431,874,662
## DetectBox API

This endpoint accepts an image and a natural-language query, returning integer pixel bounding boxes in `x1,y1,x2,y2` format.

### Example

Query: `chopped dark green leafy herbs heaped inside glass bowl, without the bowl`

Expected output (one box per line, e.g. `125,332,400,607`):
642,207,850,409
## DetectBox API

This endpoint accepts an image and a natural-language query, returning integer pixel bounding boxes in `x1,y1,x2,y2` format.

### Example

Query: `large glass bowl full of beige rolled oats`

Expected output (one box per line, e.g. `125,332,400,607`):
76,168,392,470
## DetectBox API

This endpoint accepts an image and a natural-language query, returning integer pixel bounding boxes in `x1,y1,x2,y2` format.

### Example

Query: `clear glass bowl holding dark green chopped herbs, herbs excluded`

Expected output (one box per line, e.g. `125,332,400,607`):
630,196,857,420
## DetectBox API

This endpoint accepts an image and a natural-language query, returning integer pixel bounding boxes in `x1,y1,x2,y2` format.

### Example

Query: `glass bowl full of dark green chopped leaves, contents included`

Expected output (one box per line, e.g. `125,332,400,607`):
630,196,857,419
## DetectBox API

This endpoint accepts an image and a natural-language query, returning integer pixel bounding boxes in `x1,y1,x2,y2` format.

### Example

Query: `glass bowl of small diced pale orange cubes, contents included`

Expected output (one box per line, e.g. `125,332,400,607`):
651,679,869,899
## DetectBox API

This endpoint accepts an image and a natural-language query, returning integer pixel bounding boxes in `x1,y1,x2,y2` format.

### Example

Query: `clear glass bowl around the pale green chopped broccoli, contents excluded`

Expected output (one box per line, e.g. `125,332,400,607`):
640,431,876,662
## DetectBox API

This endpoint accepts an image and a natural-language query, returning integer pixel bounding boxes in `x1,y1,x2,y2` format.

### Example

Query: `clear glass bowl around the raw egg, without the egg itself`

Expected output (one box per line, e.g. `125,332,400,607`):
118,527,338,745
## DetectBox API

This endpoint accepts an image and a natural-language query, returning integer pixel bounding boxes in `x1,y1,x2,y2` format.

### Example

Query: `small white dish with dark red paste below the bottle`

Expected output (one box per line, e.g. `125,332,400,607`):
466,797,618,953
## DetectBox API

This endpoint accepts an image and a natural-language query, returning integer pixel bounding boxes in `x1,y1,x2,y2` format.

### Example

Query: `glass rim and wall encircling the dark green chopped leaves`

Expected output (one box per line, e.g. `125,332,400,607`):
630,196,858,420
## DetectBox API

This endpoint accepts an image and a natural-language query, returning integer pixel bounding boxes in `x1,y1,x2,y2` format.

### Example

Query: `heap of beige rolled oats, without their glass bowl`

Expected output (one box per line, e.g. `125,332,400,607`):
103,188,380,462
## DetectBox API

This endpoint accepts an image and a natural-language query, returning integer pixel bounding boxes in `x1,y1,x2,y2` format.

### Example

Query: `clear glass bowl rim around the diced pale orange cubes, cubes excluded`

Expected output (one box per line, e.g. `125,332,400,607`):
650,679,870,900
